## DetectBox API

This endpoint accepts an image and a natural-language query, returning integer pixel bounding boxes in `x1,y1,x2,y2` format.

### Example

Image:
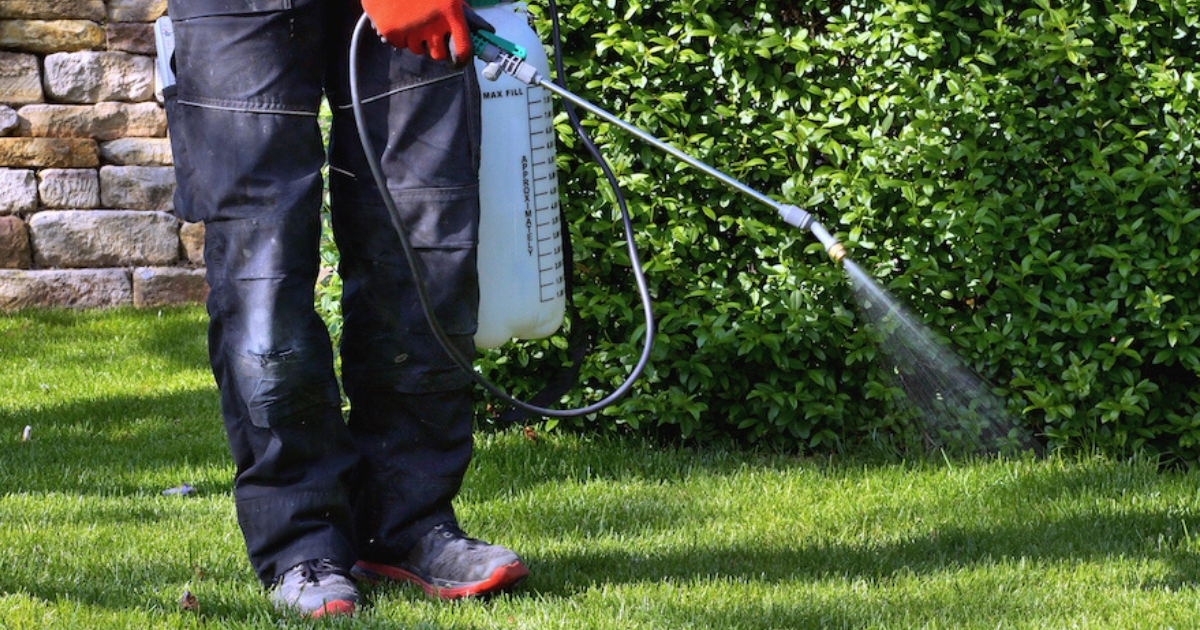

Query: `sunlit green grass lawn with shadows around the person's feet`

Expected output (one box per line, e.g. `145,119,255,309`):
0,308,1200,629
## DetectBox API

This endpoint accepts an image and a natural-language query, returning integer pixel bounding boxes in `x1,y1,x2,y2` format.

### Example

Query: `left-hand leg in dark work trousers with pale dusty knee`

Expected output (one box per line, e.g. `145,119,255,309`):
169,0,358,592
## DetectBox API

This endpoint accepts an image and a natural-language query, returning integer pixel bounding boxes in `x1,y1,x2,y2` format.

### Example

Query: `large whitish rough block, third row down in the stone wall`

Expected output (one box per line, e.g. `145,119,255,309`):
43,50,154,103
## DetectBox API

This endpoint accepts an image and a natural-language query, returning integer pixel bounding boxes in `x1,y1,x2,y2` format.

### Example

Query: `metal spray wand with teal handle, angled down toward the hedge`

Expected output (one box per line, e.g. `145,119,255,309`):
470,18,846,263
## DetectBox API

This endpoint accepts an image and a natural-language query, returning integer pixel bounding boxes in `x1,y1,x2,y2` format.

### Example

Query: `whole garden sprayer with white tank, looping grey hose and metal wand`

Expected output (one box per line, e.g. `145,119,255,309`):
350,0,846,418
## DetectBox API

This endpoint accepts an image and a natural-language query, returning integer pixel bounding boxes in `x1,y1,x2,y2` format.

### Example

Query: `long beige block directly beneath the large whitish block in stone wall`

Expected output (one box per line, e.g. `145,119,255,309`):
17,102,167,140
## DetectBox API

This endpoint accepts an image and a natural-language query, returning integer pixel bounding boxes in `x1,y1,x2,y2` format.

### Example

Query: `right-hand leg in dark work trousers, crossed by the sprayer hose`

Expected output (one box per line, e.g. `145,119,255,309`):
330,8,479,560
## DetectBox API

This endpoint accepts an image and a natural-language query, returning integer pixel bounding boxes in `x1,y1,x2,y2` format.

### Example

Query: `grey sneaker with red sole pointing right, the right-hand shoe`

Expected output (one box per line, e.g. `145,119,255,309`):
353,522,529,599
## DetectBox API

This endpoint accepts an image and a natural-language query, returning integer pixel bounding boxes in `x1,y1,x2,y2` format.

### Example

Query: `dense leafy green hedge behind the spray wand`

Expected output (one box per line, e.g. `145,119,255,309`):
328,0,1200,458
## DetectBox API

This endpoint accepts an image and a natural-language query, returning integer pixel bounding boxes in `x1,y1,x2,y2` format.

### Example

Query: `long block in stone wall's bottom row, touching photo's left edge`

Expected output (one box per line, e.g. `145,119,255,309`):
0,269,133,311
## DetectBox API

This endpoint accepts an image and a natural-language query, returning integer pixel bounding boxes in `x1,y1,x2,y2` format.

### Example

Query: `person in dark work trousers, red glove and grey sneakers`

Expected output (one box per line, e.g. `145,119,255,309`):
164,0,528,617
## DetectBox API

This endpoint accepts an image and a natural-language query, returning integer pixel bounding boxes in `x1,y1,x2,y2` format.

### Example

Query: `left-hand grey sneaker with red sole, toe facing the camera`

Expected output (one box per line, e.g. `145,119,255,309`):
271,560,359,619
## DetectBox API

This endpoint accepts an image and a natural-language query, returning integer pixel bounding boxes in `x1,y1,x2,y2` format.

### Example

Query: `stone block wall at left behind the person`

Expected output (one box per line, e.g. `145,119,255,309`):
0,0,208,311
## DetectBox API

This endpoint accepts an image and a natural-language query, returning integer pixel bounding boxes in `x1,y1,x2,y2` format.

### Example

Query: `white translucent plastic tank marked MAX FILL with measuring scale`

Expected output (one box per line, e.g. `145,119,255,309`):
472,0,566,348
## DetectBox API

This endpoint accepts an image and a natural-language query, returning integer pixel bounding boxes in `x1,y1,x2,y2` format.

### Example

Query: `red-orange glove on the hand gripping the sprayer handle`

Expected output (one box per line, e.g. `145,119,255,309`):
362,0,470,64
